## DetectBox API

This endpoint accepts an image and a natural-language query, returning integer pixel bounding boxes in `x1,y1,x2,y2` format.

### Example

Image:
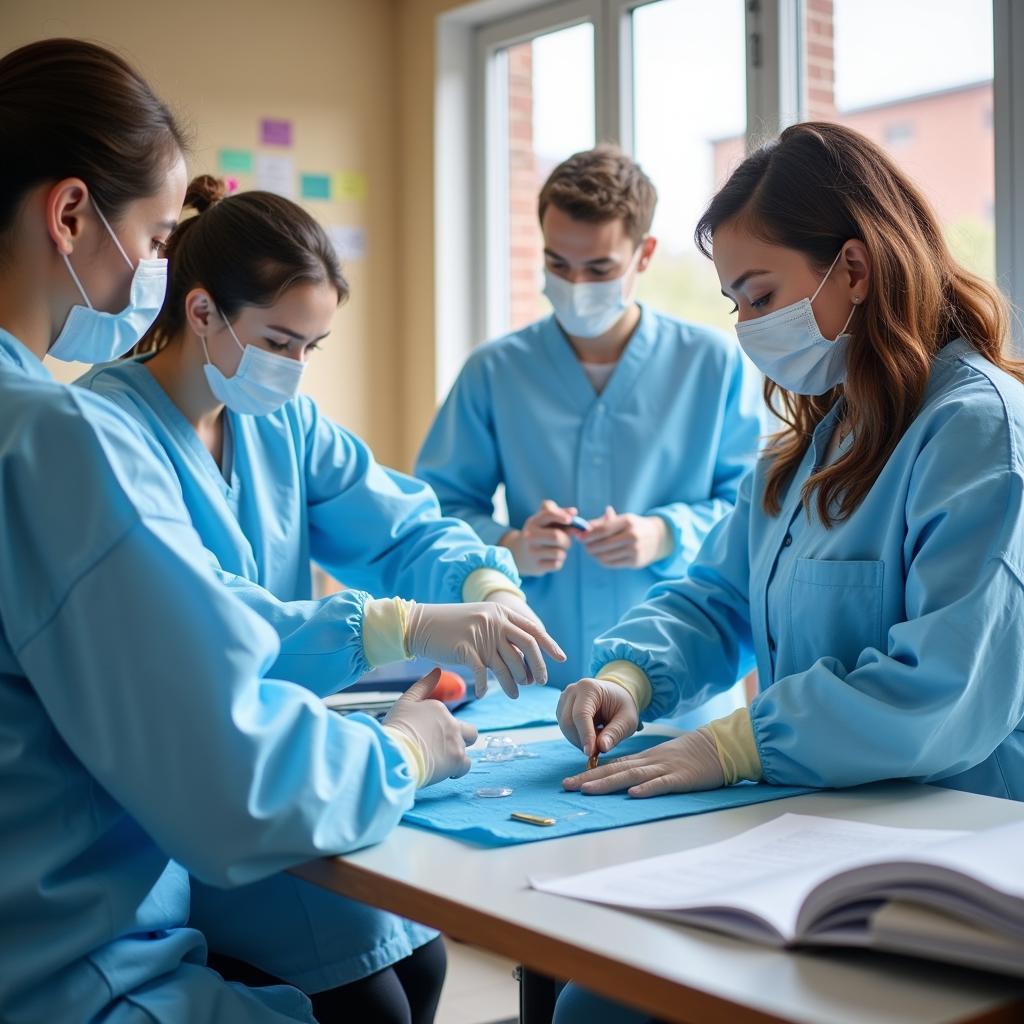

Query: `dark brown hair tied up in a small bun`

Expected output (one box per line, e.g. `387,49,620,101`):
132,174,348,355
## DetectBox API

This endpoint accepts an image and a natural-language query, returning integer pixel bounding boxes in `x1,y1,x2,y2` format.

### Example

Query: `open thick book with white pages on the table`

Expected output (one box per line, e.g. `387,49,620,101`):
530,814,1024,977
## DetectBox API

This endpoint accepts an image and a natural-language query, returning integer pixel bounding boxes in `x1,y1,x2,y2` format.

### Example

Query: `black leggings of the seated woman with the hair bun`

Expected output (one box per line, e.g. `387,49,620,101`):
208,937,447,1024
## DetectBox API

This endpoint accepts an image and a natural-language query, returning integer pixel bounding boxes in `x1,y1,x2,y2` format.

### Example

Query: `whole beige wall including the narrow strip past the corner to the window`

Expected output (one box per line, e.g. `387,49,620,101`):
0,0,479,469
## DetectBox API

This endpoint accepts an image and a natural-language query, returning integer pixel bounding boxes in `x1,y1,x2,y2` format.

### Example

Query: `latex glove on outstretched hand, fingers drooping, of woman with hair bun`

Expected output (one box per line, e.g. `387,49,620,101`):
406,601,565,699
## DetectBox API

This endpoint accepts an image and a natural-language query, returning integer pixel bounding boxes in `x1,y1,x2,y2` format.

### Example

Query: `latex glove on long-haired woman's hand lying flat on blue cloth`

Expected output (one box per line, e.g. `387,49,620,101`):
562,729,725,797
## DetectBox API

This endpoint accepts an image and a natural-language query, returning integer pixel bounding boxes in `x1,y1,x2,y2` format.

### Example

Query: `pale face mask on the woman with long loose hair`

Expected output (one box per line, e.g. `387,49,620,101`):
736,249,857,394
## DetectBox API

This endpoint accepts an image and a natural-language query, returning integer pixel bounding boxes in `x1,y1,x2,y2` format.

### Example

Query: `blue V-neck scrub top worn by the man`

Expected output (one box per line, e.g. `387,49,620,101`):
415,307,763,687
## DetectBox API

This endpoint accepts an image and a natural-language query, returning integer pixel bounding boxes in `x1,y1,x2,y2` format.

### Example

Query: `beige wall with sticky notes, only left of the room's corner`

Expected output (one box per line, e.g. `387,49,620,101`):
0,0,405,461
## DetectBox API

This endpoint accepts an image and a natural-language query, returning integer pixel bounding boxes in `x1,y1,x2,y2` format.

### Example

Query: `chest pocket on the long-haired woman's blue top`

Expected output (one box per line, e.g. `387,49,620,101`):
785,558,885,672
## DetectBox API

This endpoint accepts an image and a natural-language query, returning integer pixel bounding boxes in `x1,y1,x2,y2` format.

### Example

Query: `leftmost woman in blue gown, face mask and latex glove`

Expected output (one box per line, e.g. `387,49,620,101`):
0,40,483,1024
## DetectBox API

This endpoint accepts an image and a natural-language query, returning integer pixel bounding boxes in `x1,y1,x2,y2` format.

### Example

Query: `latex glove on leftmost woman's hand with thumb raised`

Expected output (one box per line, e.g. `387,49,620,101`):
382,669,476,786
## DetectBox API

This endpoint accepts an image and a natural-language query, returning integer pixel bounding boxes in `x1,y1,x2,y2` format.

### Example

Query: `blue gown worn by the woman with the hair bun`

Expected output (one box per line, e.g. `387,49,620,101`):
80,358,519,992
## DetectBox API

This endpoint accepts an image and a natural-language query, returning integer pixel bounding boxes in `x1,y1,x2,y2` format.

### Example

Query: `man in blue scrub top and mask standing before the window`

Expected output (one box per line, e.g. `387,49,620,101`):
415,145,762,721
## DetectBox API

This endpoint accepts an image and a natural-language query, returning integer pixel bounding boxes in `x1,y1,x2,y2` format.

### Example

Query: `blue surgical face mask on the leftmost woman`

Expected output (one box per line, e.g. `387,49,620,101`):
49,200,167,362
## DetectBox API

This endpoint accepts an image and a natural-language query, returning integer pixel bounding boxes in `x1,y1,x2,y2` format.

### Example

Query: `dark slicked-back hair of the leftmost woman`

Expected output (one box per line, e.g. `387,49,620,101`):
0,39,185,244
